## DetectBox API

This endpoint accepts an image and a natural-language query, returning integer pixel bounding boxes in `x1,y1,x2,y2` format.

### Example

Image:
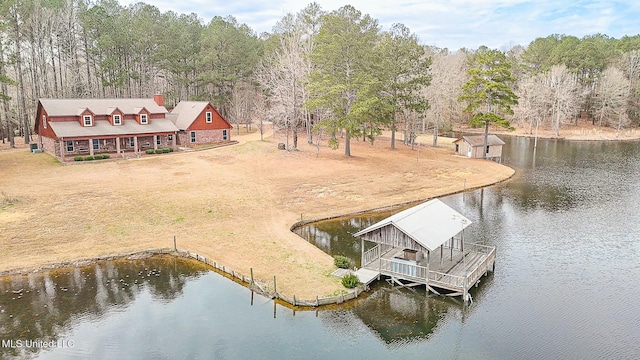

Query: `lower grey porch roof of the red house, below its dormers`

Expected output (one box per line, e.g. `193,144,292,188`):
49,119,178,138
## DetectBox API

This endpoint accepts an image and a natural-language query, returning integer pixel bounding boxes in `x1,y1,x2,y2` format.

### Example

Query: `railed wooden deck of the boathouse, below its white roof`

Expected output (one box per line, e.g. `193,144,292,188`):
358,244,496,299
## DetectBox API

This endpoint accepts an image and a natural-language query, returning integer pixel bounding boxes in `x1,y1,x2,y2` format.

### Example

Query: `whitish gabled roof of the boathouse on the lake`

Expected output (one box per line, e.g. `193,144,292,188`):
354,199,471,251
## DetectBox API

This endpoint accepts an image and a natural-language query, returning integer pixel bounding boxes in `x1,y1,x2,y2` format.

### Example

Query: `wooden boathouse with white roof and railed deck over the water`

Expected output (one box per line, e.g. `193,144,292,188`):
354,199,496,300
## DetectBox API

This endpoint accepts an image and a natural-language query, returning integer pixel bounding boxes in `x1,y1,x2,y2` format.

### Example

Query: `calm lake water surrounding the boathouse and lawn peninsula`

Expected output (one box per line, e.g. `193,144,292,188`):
0,137,640,359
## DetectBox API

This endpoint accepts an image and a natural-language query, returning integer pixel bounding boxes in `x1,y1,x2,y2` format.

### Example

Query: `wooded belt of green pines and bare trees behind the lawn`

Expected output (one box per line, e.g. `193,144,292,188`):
0,0,640,155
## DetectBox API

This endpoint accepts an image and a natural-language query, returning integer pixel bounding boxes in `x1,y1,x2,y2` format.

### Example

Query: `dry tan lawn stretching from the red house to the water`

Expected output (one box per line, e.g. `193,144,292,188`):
0,131,513,299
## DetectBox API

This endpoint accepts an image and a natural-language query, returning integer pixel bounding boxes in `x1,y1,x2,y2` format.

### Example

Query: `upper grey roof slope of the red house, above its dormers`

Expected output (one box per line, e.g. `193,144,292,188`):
40,99,168,116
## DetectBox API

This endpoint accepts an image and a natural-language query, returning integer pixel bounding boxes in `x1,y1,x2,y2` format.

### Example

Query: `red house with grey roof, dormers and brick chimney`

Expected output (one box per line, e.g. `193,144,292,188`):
35,95,231,161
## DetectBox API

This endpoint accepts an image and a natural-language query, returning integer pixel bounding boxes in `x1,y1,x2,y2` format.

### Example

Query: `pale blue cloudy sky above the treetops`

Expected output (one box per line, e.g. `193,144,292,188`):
118,0,640,50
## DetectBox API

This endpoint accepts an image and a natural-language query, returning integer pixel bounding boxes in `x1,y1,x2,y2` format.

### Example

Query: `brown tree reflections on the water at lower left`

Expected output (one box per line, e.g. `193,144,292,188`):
0,256,207,358
